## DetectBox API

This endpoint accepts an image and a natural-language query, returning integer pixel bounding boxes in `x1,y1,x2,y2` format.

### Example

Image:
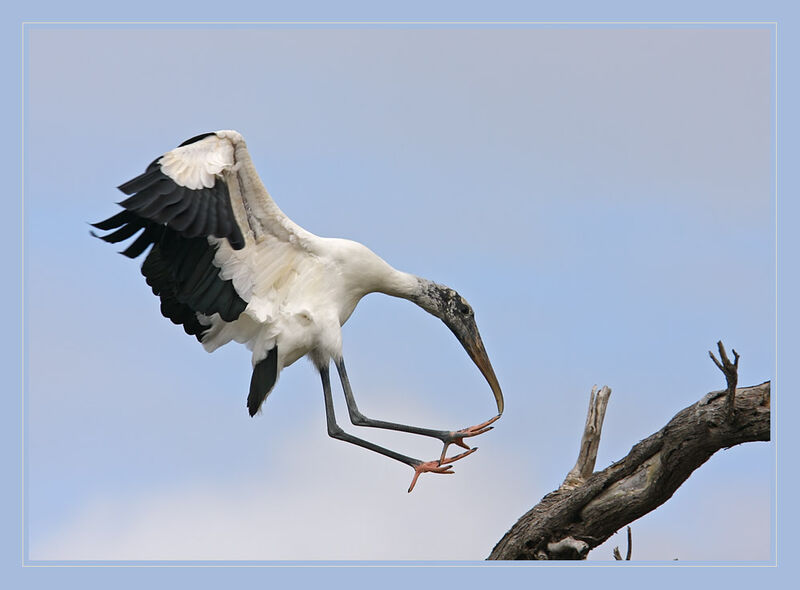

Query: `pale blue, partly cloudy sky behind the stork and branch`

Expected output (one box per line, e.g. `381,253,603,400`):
25,27,775,561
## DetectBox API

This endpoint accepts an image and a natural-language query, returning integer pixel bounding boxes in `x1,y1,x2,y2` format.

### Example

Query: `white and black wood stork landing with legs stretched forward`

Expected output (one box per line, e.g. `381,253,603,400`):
92,131,503,492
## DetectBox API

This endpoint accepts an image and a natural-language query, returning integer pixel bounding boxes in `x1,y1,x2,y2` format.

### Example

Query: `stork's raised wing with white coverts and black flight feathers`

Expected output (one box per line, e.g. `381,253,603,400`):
94,131,316,344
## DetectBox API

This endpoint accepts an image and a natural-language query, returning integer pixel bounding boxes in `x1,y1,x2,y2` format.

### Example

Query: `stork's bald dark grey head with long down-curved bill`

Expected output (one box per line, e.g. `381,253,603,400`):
416,280,503,415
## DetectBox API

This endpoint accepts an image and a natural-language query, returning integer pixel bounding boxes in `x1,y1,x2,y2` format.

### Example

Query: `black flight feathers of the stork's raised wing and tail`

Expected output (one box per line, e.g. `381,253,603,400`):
91,133,250,342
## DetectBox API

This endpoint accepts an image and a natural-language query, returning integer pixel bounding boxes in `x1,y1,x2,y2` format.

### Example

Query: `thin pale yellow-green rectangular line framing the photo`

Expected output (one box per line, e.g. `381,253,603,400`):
20,21,779,567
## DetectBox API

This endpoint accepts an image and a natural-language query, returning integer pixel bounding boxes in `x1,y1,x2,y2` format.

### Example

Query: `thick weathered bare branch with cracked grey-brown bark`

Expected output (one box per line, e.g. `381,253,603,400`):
489,382,770,559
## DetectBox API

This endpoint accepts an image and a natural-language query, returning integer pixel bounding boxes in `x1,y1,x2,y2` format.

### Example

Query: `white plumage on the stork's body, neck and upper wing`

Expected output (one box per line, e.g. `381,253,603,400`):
194,131,404,371
